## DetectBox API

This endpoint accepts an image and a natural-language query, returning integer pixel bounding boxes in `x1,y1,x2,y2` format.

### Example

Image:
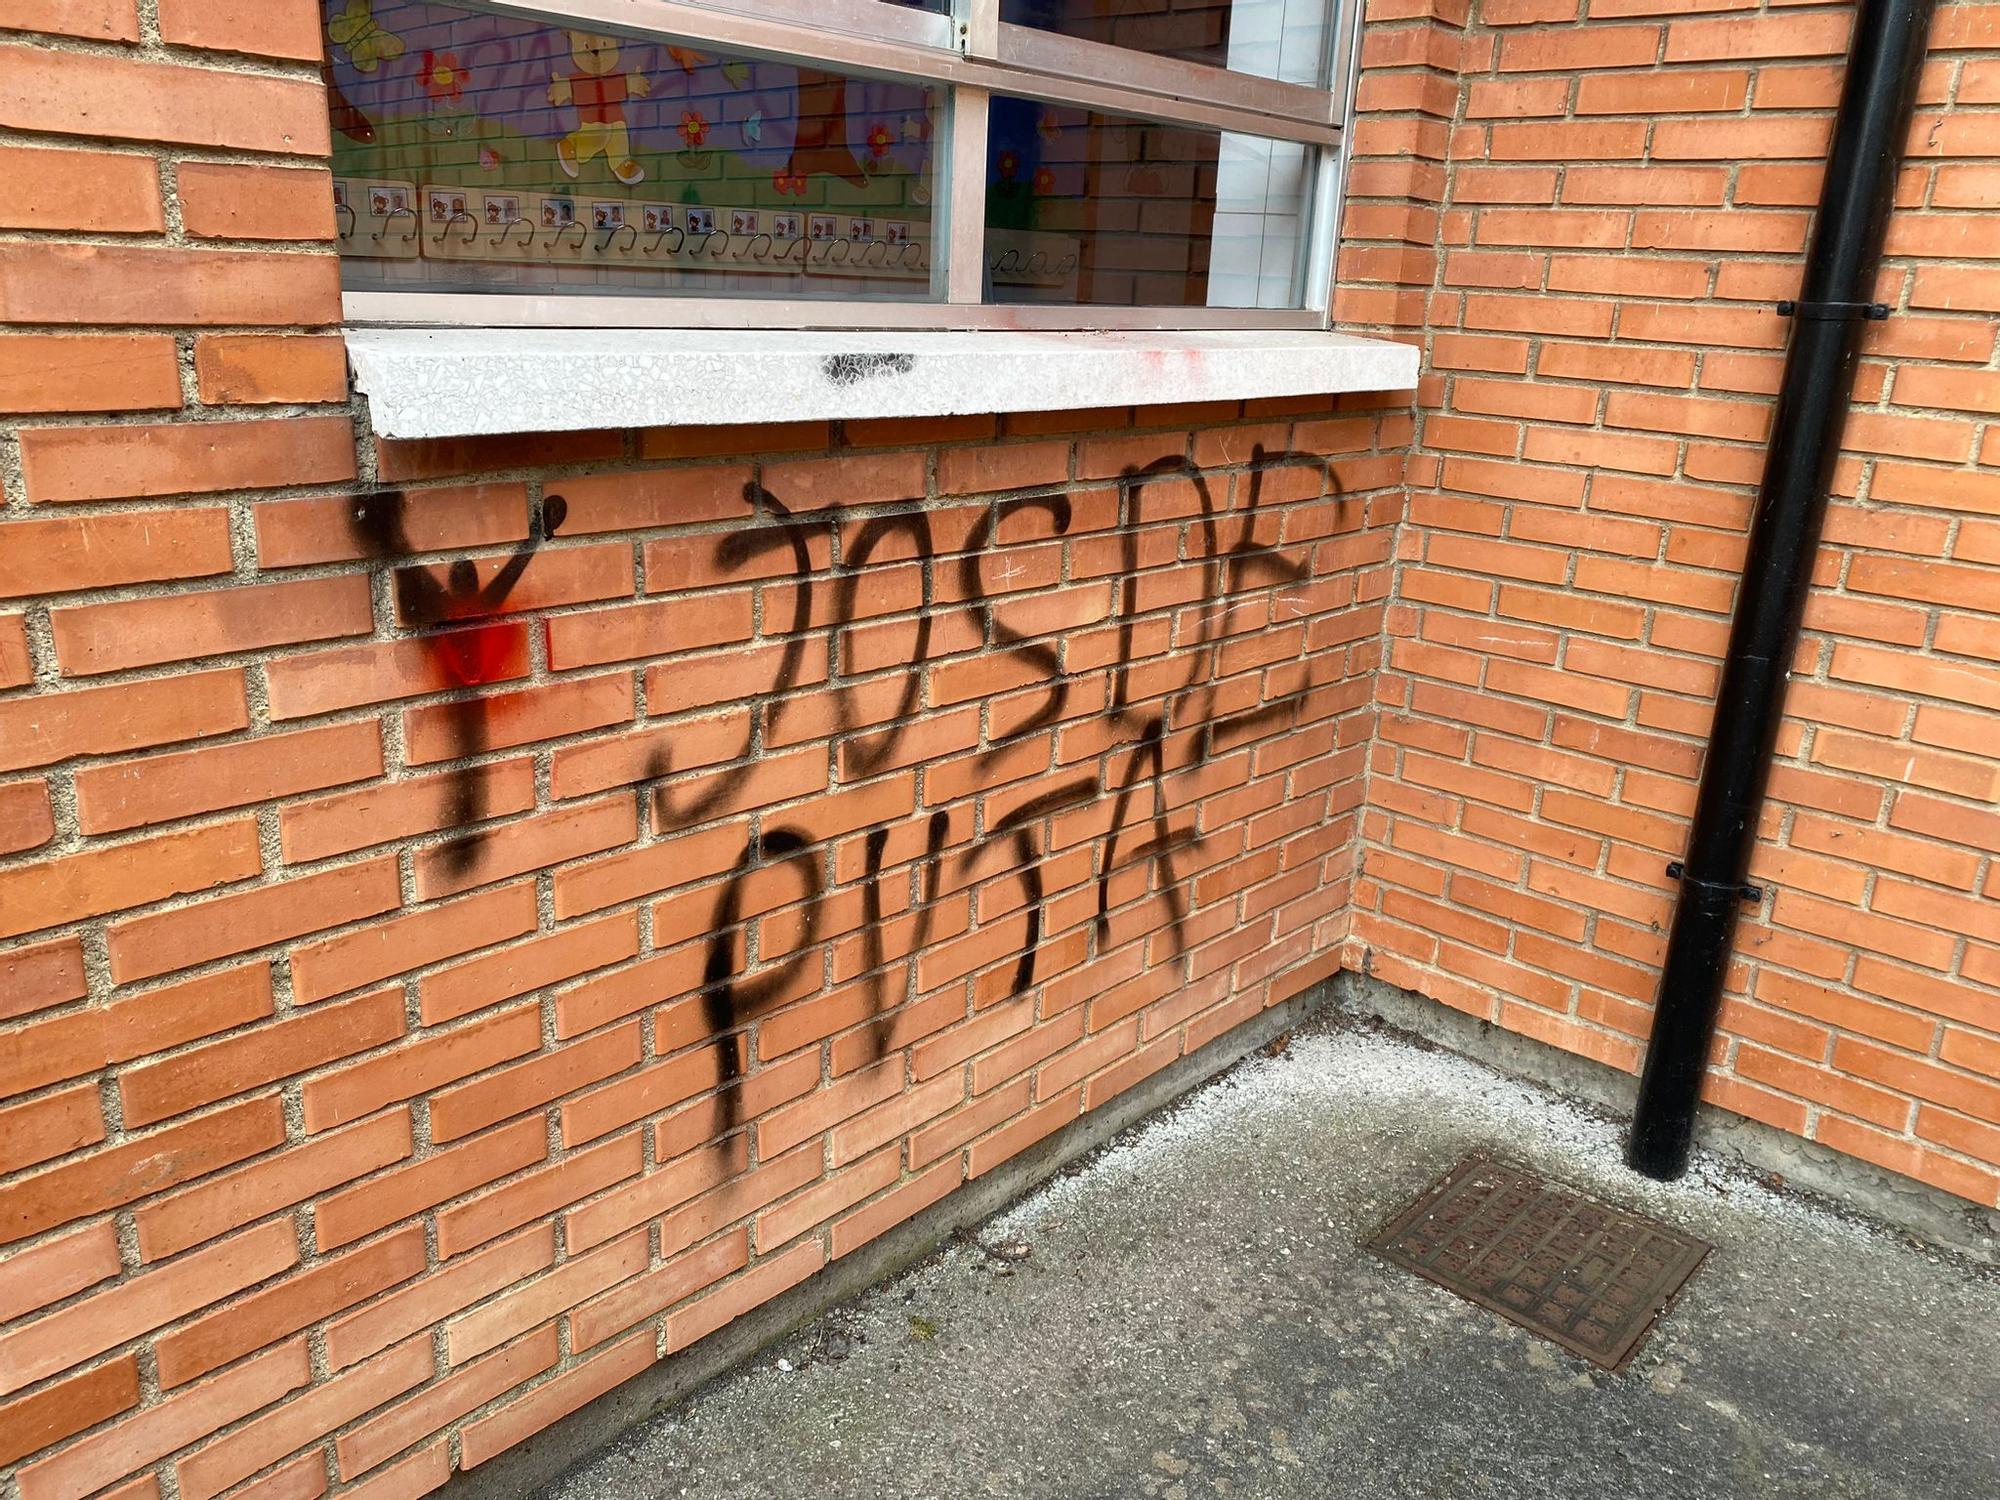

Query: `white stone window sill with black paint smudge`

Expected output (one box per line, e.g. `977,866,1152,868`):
346,328,1418,438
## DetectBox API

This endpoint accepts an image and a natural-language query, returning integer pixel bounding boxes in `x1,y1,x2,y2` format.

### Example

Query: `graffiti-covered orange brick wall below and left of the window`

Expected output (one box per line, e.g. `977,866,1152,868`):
0,0,1410,1500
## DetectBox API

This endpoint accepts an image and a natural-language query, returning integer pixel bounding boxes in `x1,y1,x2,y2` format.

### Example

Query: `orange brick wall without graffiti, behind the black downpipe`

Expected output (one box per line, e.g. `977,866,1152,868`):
1342,0,2000,1206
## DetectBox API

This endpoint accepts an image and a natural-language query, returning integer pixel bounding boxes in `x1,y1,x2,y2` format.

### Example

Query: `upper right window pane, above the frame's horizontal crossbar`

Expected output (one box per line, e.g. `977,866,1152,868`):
1000,0,1334,88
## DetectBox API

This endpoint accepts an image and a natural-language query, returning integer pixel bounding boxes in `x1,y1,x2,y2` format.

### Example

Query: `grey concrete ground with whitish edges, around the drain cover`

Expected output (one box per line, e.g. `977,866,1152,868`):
548,1028,2000,1500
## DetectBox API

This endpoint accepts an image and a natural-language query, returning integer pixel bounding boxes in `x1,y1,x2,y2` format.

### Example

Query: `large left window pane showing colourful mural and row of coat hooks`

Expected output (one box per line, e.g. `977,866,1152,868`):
324,0,944,300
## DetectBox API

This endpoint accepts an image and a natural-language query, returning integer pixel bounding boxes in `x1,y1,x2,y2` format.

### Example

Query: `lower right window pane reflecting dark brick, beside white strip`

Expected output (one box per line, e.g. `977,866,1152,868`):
986,96,1318,308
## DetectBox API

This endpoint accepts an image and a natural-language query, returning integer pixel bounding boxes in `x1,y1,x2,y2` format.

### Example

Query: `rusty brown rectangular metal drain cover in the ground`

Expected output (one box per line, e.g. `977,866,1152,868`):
1368,1152,1708,1370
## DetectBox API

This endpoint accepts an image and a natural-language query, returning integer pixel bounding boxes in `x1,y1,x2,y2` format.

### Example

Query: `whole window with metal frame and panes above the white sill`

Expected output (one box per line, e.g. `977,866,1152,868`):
322,0,1352,328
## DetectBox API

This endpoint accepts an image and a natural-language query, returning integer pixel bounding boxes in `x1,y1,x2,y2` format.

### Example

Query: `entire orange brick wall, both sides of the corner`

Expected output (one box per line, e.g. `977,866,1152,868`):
0,0,2000,1500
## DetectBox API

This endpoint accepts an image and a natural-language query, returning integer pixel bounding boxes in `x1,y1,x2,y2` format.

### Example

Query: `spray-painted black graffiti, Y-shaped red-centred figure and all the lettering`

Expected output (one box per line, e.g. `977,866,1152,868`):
352,444,1338,1134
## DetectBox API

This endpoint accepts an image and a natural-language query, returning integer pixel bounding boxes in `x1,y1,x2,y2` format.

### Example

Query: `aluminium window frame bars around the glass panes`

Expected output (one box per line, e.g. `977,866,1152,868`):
342,0,1364,330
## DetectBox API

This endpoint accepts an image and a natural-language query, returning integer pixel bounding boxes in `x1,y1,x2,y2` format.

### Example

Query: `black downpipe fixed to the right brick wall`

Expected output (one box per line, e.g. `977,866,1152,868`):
1626,0,1932,1180
